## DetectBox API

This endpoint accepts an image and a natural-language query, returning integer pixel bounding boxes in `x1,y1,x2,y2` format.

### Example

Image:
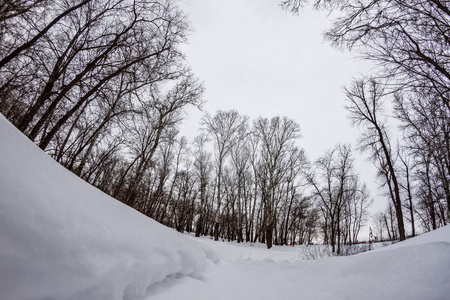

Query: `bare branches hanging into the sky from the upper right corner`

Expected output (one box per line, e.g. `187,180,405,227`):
281,0,450,109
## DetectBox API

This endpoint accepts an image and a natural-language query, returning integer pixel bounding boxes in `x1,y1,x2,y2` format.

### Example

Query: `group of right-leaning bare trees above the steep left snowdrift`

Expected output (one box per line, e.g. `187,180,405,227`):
0,0,204,211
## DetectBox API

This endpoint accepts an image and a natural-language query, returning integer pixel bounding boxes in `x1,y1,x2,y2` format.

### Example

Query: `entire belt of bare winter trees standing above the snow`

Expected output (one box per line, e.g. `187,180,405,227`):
0,0,450,255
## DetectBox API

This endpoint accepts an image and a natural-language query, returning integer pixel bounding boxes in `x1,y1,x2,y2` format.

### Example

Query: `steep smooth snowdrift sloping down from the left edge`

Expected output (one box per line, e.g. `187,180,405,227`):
0,115,207,299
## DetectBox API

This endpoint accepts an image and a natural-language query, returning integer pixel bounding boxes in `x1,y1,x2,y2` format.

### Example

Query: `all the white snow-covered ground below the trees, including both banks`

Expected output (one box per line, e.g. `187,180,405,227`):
0,115,450,300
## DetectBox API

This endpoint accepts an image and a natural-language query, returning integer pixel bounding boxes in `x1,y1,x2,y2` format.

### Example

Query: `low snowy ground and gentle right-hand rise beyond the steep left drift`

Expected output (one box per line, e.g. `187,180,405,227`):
157,226,450,300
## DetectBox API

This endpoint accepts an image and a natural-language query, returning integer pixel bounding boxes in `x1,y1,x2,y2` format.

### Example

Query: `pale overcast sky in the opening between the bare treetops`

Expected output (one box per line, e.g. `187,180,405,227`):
180,0,386,220
